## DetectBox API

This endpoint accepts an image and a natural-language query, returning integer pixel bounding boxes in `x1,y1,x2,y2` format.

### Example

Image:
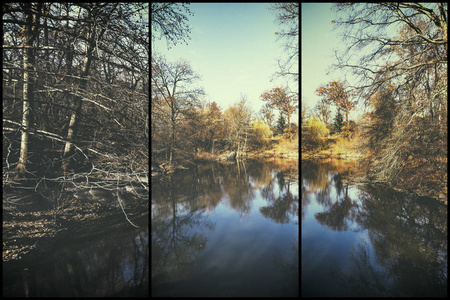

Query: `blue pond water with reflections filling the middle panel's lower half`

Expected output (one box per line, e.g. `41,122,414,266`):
151,160,299,296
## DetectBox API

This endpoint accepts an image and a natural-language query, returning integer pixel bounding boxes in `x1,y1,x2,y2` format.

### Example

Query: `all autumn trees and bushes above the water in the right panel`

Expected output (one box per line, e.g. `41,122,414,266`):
301,3,448,203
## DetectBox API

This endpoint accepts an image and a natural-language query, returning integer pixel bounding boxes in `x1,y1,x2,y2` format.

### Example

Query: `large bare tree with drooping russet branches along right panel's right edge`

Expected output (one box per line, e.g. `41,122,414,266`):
334,2,448,190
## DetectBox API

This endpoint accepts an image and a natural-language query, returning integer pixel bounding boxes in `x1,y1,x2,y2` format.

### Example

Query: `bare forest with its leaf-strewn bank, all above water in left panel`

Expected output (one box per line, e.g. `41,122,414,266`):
2,2,150,260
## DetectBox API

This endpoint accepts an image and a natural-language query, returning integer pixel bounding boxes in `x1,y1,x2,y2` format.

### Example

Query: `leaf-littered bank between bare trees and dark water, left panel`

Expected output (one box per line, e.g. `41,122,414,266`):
2,184,148,262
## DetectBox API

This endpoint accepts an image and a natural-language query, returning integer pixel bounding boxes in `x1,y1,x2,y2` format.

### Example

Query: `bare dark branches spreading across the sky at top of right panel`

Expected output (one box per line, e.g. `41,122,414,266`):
333,2,447,99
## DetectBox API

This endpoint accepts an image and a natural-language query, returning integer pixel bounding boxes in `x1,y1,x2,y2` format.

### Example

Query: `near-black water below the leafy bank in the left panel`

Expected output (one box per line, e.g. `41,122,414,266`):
3,198,149,297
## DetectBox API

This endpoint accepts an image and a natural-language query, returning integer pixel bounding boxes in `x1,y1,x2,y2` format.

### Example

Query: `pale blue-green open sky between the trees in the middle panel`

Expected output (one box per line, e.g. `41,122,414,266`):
152,3,298,119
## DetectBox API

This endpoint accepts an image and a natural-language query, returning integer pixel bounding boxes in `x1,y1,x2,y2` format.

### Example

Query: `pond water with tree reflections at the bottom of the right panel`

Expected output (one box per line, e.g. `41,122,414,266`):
301,161,447,297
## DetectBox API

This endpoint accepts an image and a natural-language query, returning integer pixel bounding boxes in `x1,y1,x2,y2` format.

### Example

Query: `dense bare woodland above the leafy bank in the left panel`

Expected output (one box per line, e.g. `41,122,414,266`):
3,3,150,185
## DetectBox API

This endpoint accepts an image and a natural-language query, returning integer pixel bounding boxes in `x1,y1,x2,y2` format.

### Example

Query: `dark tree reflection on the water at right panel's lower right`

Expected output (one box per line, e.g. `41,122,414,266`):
340,187,447,297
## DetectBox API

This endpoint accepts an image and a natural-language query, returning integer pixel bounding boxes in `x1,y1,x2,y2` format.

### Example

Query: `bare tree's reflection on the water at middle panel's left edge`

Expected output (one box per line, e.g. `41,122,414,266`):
152,177,214,285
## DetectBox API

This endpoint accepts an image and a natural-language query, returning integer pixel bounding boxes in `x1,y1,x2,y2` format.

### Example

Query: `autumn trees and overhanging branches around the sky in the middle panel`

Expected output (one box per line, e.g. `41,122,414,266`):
151,3,299,176
